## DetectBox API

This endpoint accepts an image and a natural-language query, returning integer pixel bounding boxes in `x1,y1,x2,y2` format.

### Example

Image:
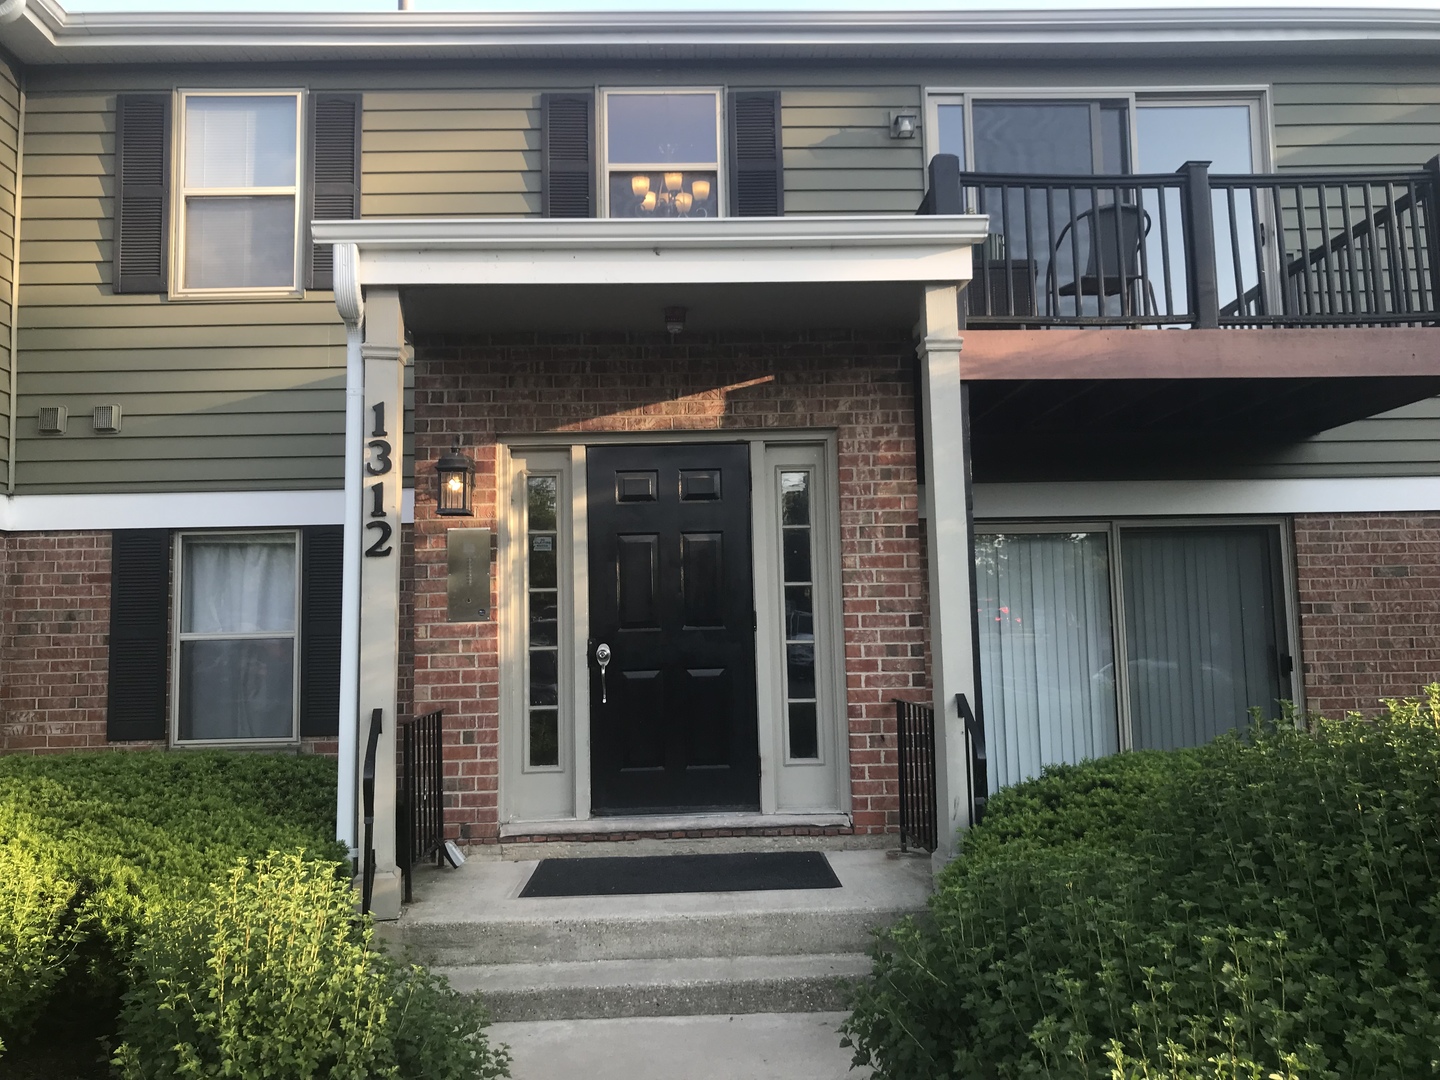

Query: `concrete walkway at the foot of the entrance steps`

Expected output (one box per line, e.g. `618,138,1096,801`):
490,1012,870,1080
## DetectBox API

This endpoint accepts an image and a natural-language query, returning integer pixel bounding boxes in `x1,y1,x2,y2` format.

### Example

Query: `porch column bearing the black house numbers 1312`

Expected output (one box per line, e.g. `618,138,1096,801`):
350,289,405,919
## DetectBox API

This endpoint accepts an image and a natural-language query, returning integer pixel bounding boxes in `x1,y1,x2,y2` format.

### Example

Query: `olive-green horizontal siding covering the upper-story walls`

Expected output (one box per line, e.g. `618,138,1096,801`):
0,60,1440,492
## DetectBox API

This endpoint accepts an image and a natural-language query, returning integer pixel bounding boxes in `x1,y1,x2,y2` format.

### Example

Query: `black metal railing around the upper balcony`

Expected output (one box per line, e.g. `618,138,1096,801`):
920,156,1440,328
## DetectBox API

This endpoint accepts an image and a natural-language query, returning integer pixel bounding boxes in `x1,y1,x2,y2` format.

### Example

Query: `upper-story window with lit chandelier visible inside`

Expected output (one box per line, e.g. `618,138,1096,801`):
600,89,723,217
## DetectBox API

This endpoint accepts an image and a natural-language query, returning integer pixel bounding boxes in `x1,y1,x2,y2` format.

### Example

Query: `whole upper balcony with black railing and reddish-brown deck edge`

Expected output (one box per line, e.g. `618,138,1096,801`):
920,156,1440,480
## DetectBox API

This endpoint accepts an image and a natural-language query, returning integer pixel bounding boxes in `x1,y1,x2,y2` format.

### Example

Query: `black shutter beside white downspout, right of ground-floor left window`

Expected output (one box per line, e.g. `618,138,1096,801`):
300,526,346,736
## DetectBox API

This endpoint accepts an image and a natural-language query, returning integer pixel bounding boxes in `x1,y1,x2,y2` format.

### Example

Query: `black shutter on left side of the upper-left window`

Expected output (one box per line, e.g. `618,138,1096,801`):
114,94,170,292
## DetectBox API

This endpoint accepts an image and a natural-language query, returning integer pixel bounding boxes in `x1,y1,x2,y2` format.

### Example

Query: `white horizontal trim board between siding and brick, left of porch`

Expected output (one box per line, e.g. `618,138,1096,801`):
0,488,415,533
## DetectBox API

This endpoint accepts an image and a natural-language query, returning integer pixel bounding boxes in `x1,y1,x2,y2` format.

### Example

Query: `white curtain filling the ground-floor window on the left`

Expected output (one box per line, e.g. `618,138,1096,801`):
179,537,297,739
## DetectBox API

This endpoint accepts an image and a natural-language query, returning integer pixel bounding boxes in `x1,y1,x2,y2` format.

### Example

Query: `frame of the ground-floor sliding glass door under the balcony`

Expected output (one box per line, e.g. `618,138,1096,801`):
975,516,1305,752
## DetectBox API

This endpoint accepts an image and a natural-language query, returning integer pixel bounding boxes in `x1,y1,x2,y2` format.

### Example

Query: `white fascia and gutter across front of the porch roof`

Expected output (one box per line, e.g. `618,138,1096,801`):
311,215,988,285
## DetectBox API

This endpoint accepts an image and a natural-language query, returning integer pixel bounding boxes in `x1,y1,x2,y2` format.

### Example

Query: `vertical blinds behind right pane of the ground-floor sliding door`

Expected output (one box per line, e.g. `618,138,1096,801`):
1120,526,1280,749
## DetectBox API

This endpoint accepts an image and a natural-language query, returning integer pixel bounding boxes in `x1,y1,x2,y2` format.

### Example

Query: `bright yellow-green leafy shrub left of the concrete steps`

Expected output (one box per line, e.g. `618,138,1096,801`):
115,854,508,1080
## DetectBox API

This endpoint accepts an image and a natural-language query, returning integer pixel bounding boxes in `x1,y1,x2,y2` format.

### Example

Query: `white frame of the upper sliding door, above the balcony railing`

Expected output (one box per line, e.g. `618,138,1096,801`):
924,84,1274,173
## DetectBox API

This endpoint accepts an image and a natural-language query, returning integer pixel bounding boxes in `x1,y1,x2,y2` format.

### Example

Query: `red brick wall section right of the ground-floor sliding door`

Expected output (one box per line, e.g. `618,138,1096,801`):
1295,513,1440,716
